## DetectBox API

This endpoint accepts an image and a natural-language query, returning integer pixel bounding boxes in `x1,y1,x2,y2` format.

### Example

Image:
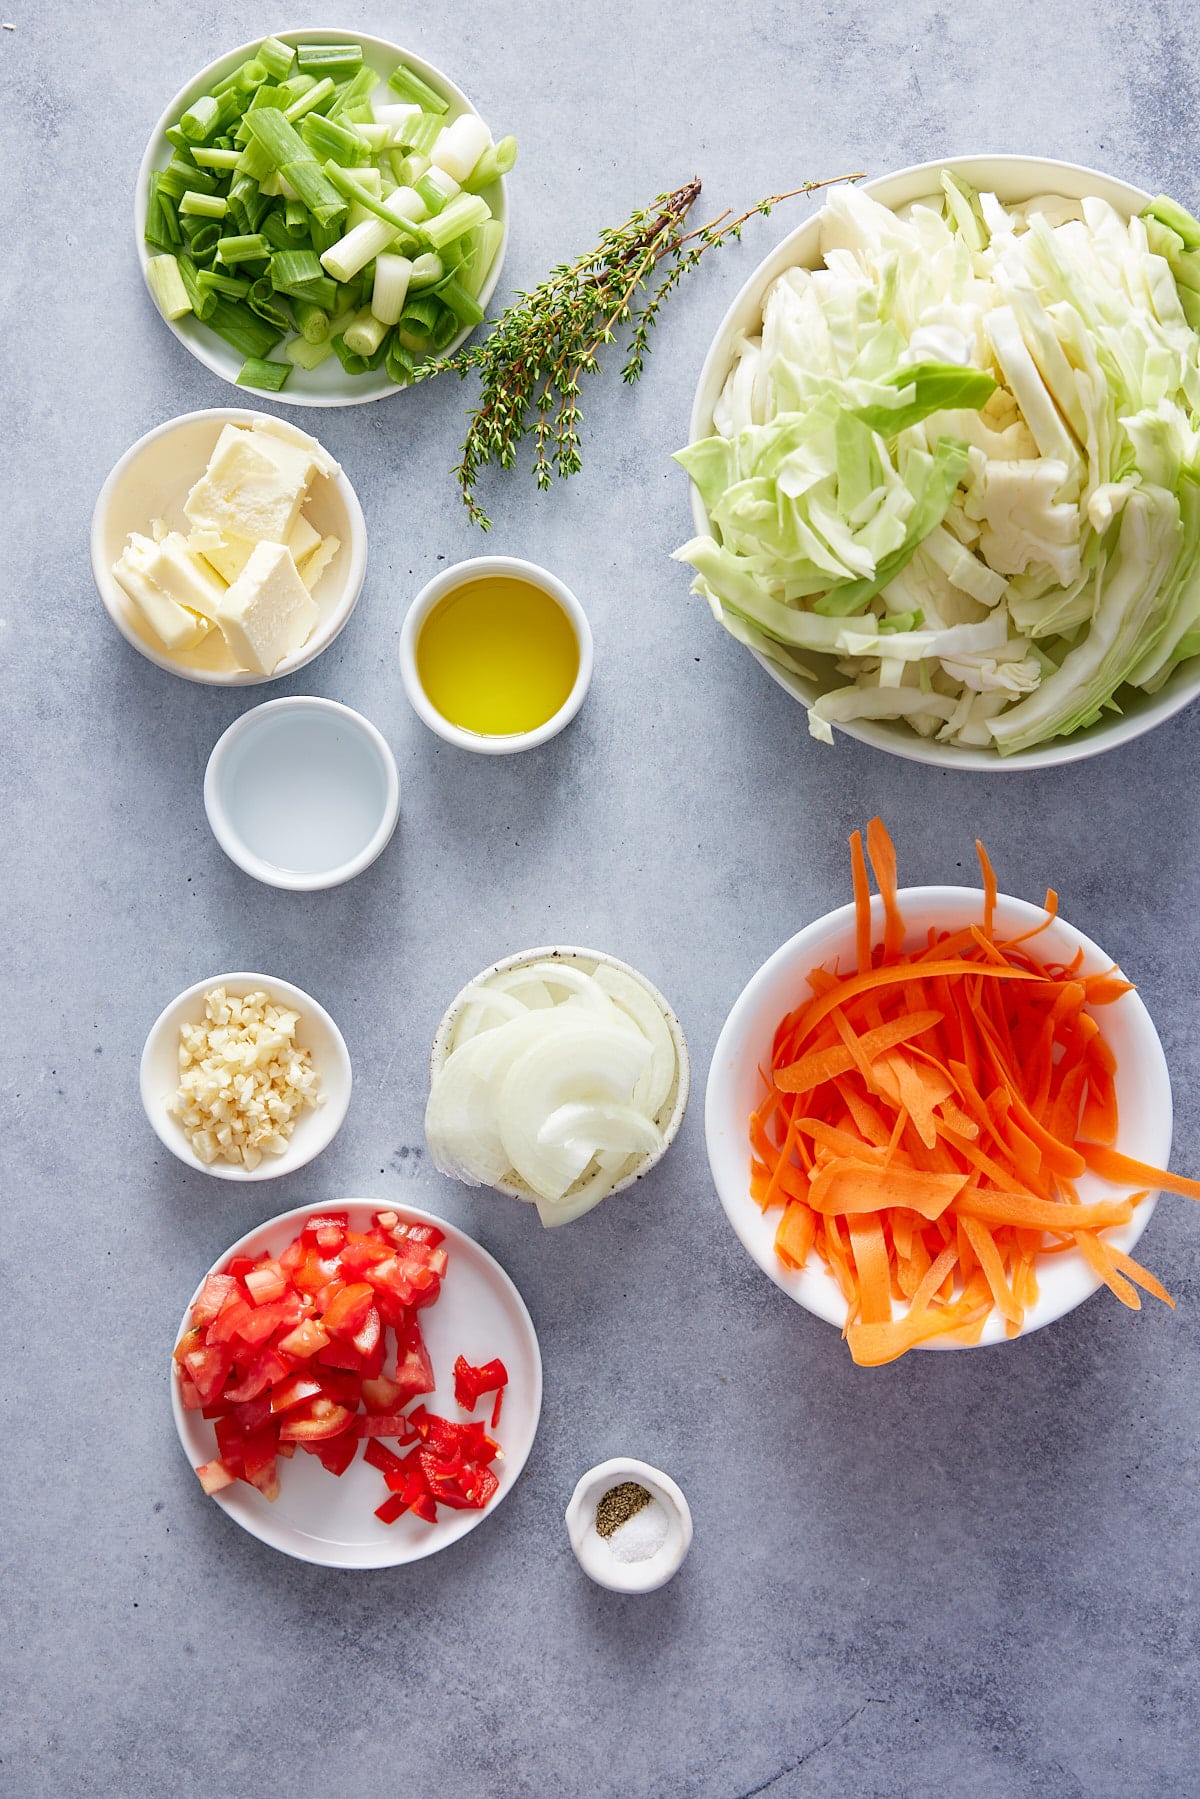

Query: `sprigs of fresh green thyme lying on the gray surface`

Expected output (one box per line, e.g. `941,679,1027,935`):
417,175,860,531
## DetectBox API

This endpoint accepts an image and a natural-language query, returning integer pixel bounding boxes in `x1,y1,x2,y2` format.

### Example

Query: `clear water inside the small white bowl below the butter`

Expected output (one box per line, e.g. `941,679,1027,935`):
225,711,387,874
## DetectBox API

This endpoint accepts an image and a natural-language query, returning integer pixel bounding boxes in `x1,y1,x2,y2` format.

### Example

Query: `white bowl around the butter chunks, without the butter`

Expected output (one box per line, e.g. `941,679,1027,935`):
90,407,367,687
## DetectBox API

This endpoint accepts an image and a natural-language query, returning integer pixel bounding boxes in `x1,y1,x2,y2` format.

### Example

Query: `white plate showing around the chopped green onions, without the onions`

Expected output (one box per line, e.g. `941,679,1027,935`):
133,31,509,407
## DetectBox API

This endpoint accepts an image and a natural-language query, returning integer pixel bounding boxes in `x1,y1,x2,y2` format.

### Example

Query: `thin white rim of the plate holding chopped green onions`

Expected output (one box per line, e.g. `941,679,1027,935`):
133,25,509,407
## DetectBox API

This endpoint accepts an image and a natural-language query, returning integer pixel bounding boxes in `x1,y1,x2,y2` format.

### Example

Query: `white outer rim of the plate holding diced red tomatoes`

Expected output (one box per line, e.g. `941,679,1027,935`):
171,1198,542,1569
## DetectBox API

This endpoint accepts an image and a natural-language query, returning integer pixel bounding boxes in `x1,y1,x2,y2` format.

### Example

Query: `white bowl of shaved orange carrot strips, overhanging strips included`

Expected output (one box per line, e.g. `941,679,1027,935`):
705,820,1200,1365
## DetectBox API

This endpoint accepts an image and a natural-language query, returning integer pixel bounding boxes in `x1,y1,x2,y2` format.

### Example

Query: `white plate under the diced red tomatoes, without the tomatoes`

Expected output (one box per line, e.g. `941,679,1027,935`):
171,1200,542,1569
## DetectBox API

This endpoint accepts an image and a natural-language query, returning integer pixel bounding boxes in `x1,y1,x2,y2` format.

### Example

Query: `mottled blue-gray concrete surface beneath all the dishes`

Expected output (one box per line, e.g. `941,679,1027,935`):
0,0,1200,1799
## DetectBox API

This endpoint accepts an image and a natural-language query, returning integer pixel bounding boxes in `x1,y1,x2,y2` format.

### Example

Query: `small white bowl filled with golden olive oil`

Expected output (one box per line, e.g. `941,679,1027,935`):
399,556,592,756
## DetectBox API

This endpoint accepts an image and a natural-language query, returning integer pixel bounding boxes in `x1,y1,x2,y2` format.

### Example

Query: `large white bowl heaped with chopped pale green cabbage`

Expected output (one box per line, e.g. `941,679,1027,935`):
676,157,1200,770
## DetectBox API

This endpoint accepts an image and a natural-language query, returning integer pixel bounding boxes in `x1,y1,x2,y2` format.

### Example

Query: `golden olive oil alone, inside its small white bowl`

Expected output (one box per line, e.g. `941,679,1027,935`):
417,576,579,738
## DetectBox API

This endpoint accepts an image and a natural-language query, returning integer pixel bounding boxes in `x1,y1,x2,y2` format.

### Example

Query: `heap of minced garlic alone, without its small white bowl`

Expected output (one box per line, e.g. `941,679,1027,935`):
171,988,324,1169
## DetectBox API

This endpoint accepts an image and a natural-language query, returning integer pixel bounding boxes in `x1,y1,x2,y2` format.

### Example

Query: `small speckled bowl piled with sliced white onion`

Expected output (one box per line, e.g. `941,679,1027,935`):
425,946,691,1225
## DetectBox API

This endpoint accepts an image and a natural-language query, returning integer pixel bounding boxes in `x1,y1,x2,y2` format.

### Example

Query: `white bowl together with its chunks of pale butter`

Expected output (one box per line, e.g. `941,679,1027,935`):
92,407,367,687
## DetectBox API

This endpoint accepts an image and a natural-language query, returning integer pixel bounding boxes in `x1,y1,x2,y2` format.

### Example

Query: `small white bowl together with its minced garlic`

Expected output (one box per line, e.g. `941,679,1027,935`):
140,973,351,1180
